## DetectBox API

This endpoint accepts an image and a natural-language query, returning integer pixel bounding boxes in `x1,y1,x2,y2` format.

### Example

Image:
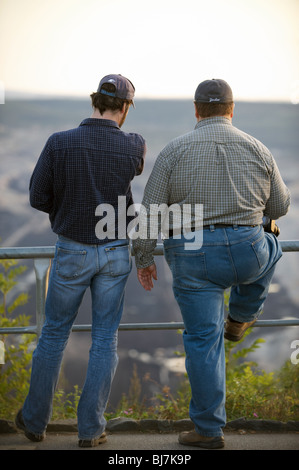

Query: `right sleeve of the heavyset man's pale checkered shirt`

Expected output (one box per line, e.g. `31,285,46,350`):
264,157,291,220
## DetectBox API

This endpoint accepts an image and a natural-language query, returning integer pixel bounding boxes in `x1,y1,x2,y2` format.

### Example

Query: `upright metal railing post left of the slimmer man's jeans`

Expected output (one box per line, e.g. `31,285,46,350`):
34,258,51,338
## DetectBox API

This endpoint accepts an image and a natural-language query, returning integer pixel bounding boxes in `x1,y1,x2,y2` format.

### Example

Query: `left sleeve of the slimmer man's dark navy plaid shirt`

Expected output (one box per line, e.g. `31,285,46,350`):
29,139,54,214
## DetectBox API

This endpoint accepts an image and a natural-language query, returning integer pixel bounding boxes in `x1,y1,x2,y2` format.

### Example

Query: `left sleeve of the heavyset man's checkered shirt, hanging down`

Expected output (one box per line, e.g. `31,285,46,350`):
133,152,169,268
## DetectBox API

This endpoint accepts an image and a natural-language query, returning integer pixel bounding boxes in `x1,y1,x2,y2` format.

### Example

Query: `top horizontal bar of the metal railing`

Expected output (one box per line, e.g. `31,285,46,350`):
0,240,299,259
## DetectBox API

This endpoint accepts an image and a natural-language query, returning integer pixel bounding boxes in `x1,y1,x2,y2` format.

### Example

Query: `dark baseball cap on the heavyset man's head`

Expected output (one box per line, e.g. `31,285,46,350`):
194,78,234,103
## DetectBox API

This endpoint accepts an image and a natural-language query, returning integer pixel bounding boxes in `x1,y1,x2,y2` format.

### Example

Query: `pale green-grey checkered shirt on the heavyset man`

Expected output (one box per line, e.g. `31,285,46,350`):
133,116,290,268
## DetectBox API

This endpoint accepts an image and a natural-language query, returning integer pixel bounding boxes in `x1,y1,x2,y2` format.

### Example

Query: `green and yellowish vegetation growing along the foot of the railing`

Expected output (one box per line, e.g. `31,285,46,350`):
0,260,299,421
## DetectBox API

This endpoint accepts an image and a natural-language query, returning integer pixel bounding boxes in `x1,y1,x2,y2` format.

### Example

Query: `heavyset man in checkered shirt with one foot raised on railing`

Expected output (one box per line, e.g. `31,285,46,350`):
133,79,290,448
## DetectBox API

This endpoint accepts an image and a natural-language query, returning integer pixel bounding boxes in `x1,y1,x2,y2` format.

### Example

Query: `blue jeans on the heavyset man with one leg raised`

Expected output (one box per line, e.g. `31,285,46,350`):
164,226,282,437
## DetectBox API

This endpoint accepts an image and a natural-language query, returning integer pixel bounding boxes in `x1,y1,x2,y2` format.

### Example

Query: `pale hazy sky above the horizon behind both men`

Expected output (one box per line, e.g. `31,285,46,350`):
0,0,299,102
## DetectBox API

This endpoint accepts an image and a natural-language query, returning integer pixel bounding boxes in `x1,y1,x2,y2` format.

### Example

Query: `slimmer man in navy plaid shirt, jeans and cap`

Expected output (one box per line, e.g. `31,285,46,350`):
16,75,145,447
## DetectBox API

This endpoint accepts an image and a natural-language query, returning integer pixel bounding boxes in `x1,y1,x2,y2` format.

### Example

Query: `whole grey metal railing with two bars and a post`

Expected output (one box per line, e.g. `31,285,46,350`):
0,240,299,337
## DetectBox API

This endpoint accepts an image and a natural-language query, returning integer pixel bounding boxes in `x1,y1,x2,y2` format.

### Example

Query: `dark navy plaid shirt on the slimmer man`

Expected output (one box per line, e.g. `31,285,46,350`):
29,118,145,244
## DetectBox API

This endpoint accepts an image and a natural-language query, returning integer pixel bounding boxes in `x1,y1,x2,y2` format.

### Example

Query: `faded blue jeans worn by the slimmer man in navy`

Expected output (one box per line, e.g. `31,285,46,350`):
23,236,132,439
